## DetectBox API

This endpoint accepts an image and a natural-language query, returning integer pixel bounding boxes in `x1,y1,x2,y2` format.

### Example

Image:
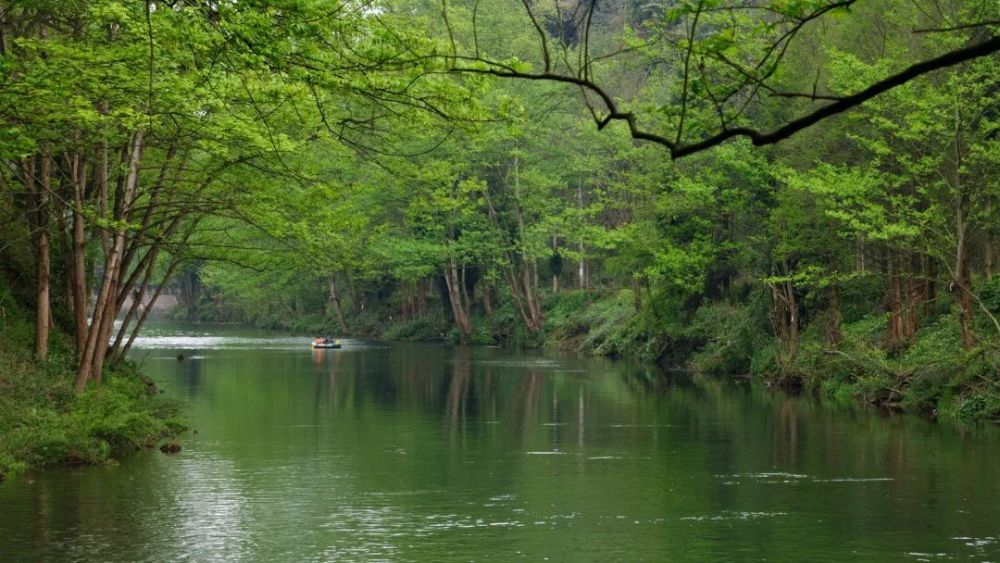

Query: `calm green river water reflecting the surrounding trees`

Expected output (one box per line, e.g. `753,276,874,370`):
0,327,1000,562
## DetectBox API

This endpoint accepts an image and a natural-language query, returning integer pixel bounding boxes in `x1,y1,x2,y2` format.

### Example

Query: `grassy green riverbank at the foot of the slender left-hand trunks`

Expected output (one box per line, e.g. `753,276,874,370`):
0,302,186,480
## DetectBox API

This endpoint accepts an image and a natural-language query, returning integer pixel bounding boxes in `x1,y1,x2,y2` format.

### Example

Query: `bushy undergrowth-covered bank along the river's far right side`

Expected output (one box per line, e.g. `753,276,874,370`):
234,289,1000,422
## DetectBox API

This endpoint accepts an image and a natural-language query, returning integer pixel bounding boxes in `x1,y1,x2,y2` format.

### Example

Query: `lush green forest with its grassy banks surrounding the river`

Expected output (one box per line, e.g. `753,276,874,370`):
0,0,1000,471
